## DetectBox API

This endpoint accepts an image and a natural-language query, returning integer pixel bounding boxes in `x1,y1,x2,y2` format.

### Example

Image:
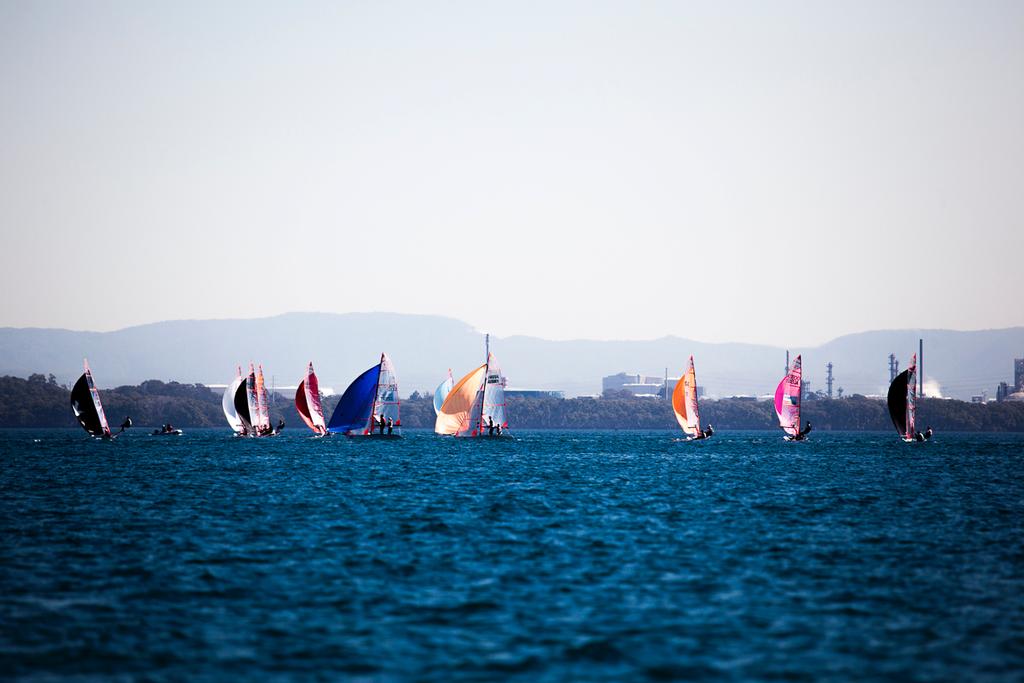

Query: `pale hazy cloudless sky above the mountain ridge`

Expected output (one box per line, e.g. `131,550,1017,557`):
0,0,1024,346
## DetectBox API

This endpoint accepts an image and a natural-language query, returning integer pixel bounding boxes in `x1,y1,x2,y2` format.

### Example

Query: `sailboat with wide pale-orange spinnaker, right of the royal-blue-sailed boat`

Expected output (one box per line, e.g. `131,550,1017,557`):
434,337,509,436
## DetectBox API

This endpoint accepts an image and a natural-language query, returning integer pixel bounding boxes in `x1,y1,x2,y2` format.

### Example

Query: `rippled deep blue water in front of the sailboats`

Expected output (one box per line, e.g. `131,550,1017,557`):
0,430,1024,681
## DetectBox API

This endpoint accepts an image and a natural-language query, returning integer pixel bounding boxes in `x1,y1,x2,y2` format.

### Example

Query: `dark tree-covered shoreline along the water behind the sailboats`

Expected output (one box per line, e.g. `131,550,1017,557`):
0,375,1024,432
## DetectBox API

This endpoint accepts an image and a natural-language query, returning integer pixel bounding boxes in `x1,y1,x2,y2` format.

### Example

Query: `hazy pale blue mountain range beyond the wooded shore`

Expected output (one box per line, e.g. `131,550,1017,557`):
0,313,1024,399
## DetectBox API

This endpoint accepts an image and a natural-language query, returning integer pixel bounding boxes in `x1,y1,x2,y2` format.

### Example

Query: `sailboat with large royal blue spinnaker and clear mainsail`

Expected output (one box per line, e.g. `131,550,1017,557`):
327,353,401,436
